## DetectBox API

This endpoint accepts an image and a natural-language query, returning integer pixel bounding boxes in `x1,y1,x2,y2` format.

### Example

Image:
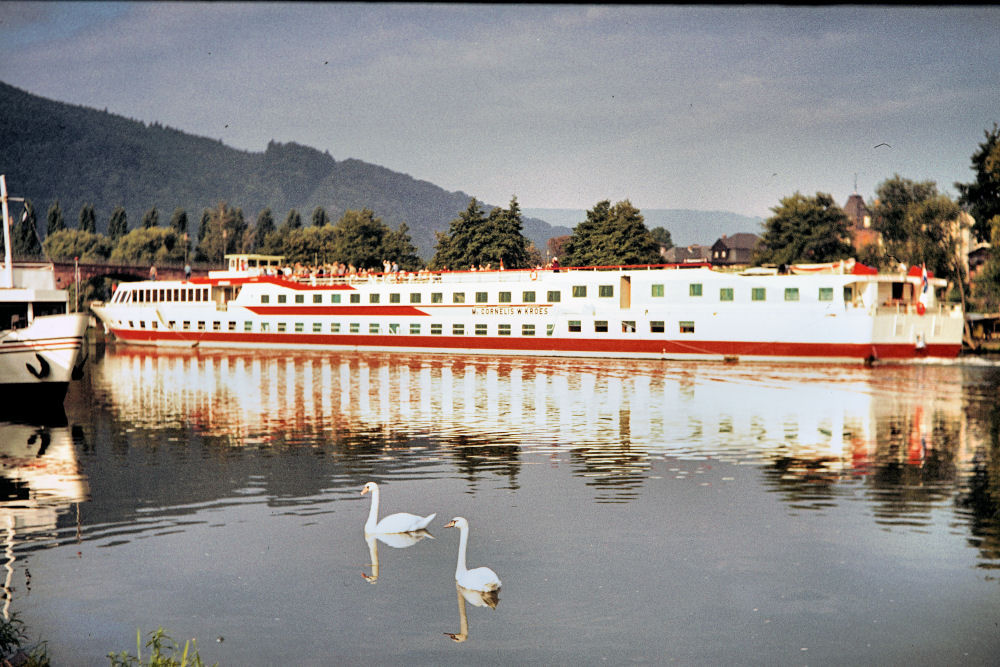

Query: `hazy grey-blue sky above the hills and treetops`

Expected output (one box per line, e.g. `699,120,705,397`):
0,2,1000,217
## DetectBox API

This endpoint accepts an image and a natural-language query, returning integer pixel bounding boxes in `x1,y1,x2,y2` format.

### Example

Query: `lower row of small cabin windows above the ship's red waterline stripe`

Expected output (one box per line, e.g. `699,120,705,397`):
128,320,694,336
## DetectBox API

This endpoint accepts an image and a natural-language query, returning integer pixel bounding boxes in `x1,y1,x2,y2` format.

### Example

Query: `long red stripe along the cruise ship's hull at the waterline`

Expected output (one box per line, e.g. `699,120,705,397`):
107,329,961,361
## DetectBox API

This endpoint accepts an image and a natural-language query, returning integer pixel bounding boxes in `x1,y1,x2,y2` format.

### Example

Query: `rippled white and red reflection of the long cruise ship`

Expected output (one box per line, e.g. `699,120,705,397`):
94,348,1000,576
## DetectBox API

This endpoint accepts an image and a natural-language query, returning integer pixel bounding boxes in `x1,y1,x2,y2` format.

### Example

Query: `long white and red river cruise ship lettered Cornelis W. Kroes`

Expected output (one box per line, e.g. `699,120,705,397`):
91,255,964,363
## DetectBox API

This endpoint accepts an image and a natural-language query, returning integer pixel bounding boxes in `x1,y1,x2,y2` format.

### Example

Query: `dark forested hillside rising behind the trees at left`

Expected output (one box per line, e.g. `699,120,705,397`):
0,83,570,258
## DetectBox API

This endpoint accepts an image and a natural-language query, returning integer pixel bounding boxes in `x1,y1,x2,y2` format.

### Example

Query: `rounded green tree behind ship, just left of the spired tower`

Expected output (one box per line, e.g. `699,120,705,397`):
754,192,852,264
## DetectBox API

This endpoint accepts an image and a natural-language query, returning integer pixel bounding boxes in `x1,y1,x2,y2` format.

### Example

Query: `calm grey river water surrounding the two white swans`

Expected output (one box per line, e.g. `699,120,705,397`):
0,346,1000,665
